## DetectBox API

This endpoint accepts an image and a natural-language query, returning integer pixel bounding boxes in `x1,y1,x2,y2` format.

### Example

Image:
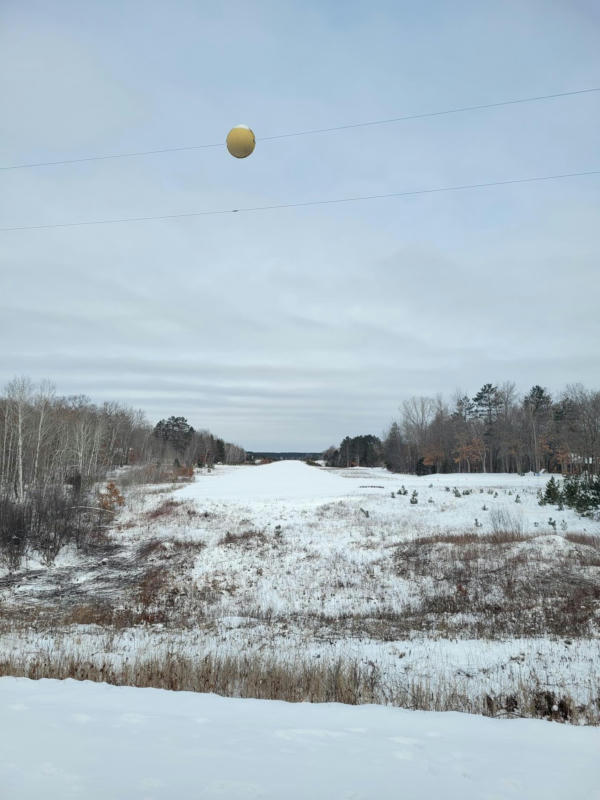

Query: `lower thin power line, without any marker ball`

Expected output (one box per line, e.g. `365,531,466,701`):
0,169,600,233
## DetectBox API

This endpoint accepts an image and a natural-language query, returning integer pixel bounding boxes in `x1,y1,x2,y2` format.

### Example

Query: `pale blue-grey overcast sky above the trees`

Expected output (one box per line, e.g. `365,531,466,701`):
0,0,600,450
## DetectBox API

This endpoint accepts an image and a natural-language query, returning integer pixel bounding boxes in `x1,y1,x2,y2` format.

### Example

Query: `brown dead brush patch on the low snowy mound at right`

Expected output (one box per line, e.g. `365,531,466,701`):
394,531,600,638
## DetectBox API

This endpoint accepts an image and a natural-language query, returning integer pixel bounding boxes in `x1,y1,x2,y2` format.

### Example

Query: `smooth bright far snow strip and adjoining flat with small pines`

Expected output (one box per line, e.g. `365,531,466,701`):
171,461,600,535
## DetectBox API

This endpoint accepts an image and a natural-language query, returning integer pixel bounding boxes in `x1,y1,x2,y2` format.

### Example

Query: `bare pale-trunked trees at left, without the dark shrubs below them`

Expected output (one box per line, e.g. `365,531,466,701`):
0,378,246,500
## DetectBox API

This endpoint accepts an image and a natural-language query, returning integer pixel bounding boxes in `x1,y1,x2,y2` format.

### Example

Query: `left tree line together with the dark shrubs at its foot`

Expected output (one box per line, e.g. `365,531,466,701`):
0,378,246,567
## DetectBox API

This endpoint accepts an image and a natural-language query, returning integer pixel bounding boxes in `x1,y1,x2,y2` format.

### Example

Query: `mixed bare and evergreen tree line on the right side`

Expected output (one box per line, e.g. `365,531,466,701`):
323,383,600,475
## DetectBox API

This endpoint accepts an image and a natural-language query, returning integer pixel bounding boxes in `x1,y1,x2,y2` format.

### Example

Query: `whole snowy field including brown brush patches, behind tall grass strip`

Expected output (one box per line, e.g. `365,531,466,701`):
0,462,600,721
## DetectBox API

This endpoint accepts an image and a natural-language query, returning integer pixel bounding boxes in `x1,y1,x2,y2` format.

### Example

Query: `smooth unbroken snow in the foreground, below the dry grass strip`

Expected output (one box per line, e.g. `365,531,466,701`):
0,678,600,800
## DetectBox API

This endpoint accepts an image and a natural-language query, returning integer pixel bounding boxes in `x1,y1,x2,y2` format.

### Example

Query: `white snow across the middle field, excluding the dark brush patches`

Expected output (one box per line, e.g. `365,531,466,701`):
0,461,600,724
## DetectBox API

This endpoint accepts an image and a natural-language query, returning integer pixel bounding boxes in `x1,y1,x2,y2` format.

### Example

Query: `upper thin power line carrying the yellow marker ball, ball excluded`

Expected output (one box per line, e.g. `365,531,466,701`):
0,87,600,171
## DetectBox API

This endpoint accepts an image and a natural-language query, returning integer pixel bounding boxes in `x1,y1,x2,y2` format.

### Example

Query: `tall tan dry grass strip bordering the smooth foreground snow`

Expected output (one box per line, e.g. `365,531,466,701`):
0,655,600,725
